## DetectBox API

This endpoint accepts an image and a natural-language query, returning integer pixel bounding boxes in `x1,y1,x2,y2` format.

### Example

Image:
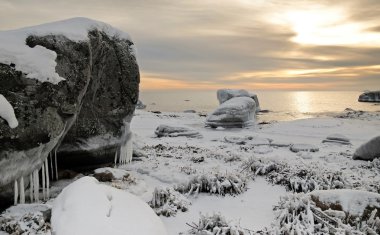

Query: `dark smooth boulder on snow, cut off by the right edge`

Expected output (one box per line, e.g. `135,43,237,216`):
353,136,380,161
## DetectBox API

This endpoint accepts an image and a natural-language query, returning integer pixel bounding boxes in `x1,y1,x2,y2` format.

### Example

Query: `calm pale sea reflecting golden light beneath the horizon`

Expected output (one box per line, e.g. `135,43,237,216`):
140,91,380,121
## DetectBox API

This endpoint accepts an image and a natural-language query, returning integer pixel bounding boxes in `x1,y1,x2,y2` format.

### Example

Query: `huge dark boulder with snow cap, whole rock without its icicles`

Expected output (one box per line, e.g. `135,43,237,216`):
0,18,139,205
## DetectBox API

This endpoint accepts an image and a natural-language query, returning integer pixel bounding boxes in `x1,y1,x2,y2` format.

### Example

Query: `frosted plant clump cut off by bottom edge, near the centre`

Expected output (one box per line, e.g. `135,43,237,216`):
187,214,253,235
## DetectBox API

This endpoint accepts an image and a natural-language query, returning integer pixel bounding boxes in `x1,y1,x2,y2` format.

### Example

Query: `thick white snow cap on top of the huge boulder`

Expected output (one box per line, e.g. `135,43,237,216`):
0,18,132,84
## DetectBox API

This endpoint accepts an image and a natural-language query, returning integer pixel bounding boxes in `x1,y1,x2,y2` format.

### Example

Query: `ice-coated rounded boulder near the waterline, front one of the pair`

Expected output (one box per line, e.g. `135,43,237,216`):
205,97,256,128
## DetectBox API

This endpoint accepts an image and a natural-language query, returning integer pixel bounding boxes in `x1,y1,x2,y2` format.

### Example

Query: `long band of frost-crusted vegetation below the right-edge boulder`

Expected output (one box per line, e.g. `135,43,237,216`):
242,157,380,193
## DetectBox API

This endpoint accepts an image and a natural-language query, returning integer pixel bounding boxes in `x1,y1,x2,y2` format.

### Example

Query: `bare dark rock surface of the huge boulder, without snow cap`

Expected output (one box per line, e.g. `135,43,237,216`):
0,29,140,196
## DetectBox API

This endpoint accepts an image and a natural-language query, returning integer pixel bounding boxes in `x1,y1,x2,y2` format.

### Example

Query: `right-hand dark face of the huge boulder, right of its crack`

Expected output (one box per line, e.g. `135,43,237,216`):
58,31,140,167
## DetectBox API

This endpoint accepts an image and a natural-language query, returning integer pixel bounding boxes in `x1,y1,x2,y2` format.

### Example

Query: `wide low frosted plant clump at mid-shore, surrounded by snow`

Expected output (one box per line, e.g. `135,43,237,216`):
175,173,247,195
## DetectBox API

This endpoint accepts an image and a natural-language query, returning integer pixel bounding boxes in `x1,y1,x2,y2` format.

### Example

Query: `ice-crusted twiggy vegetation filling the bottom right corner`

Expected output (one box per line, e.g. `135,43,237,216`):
266,193,380,235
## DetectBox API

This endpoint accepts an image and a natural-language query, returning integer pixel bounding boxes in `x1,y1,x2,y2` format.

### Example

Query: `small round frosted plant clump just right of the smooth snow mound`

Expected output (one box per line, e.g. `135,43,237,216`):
149,188,191,217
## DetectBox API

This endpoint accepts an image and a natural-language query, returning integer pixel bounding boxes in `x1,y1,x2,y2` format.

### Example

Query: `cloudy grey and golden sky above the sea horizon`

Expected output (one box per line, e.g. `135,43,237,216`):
0,0,380,91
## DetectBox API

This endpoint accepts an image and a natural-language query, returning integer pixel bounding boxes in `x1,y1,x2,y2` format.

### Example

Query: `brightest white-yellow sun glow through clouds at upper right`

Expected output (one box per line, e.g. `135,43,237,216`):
275,6,380,47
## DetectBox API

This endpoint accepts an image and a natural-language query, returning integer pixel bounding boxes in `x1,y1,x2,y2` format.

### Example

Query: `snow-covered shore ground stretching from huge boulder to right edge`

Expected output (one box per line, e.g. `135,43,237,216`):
0,110,380,235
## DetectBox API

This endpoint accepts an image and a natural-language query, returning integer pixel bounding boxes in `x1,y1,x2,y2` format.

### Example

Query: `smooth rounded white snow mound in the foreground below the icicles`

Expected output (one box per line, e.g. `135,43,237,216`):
51,177,167,235
